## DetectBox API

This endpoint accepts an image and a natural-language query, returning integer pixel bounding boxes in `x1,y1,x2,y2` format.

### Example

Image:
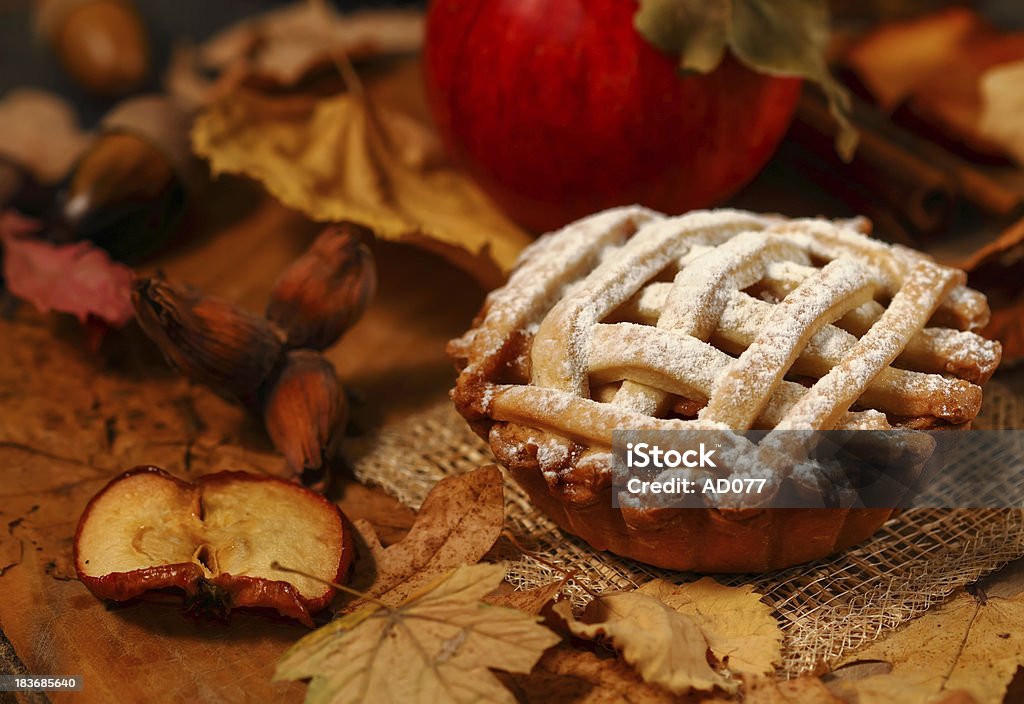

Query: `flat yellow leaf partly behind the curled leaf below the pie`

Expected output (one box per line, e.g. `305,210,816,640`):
637,577,782,675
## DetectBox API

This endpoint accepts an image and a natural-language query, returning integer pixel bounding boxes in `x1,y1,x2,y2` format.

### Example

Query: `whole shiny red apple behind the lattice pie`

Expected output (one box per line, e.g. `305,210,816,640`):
424,0,801,230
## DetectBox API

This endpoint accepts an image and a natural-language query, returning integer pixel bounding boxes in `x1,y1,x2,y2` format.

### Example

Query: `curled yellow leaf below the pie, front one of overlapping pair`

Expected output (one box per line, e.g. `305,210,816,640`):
554,591,736,694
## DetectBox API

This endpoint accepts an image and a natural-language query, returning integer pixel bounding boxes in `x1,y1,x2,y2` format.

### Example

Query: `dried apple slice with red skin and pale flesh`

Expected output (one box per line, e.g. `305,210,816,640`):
75,467,352,626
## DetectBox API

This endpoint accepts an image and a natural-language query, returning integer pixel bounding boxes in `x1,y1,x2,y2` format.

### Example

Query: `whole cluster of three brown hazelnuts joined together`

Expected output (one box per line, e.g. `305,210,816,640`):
132,223,377,486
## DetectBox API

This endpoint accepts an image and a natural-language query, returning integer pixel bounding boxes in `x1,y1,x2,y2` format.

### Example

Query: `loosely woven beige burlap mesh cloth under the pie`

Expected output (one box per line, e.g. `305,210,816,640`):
354,382,1024,675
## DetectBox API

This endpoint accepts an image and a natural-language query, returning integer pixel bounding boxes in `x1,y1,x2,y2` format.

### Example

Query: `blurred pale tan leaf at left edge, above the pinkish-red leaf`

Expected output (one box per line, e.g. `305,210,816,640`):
0,88,90,183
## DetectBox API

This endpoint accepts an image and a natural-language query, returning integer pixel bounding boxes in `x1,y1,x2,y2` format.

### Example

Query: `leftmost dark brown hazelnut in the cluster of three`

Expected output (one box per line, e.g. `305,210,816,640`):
132,278,285,403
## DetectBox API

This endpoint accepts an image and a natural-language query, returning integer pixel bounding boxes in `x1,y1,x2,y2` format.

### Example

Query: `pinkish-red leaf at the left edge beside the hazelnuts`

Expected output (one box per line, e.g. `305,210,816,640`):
0,216,135,327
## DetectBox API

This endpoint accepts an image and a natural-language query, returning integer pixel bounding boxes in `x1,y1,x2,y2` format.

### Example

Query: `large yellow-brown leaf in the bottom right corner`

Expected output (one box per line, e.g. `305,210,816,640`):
829,591,1024,704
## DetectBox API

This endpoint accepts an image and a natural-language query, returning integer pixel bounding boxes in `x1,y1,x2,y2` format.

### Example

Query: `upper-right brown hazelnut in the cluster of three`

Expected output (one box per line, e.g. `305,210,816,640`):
266,222,377,350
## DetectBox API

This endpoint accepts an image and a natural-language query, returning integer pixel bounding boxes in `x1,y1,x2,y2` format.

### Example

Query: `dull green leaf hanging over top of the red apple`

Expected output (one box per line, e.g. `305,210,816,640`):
634,0,857,161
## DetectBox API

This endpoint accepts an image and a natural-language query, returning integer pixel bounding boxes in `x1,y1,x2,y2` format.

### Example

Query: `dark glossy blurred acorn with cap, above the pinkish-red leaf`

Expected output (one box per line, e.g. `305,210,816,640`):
50,95,201,260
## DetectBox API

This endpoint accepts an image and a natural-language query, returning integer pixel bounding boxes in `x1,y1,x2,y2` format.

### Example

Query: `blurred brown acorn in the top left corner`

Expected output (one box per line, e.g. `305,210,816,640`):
37,0,150,96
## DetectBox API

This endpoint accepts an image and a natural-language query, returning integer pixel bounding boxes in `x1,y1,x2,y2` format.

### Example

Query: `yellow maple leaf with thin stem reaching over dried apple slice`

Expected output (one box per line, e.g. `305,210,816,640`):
274,564,559,704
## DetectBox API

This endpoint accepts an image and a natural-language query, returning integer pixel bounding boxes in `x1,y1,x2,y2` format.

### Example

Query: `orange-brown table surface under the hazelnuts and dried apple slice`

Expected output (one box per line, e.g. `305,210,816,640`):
0,181,482,703
